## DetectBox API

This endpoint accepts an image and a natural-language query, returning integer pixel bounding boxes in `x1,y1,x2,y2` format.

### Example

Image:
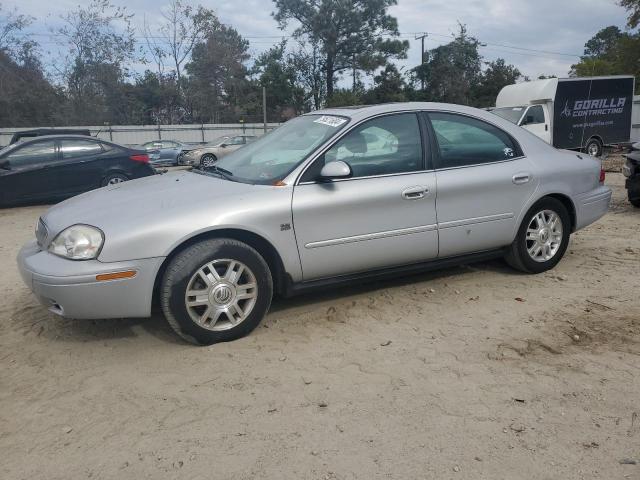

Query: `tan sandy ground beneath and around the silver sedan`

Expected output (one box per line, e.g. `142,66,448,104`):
0,174,640,480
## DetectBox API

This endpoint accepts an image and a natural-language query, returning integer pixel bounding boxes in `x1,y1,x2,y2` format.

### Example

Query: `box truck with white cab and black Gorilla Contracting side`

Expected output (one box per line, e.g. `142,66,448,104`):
492,75,635,156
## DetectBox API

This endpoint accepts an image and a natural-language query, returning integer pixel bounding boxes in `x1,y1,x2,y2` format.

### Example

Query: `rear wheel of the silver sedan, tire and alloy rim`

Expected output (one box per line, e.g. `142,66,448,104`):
506,197,571,273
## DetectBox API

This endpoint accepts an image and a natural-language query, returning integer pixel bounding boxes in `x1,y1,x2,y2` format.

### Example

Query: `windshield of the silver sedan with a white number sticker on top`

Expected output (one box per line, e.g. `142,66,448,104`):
209,115,348,185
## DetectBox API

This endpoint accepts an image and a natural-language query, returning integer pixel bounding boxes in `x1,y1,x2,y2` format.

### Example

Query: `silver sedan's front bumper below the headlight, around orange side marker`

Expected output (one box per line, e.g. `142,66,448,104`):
17,241,164,319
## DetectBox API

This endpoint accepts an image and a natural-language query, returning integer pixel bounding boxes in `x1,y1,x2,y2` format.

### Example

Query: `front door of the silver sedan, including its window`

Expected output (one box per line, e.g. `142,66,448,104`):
292,113,438,281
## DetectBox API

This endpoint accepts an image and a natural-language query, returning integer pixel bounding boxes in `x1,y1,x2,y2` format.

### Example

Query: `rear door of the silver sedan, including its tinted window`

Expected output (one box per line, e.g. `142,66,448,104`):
428,112,538,258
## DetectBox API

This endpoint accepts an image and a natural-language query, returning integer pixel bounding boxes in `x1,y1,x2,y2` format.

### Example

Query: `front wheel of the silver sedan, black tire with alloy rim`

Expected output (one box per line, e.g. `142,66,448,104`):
160,238,273,345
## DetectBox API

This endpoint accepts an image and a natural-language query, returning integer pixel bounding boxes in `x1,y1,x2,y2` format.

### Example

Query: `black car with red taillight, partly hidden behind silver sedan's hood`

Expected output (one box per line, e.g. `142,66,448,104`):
0,135,155,206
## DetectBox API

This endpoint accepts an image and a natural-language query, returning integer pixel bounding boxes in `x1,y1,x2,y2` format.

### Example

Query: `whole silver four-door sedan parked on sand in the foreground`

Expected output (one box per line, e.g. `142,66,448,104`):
18,103,611,344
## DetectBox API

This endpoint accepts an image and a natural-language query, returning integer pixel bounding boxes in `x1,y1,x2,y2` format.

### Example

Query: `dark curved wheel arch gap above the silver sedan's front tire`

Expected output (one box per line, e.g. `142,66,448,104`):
152,228,287,305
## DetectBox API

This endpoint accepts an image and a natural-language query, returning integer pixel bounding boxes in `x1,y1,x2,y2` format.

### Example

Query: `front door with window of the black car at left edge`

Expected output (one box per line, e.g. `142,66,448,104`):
0,140,59,203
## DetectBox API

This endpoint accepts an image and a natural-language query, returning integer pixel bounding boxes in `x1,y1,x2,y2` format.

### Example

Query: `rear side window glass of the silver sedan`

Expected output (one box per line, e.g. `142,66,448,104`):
429,113,521,168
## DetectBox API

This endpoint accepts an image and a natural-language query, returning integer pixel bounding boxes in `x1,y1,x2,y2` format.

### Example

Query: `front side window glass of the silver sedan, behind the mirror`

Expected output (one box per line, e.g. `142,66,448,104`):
302,113,424,181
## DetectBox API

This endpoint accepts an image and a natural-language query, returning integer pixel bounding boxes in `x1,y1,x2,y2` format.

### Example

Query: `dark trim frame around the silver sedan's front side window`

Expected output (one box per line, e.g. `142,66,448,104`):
294,110,434,185
